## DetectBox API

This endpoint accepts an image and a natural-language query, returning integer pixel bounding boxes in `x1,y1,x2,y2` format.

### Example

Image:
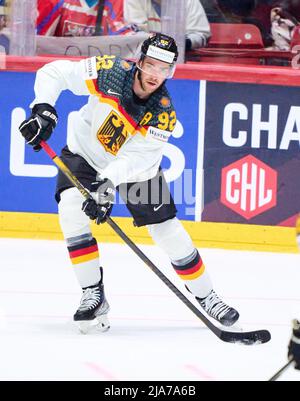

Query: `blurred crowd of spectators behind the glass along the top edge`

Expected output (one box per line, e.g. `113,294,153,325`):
0,0,300,50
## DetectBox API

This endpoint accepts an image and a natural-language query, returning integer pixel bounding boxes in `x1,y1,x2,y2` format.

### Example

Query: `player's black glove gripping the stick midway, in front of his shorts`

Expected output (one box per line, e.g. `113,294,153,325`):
82,178,116,224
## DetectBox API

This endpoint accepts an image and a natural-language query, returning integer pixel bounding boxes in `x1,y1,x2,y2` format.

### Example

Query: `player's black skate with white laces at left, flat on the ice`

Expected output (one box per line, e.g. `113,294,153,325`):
74,276,110,334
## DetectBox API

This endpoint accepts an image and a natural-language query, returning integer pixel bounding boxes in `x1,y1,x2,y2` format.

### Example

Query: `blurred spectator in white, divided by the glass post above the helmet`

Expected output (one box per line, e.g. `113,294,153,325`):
124,0,210,50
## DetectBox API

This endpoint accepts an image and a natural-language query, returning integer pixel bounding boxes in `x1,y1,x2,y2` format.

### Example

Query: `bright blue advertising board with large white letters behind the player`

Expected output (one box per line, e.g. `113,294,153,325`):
0,71,199,220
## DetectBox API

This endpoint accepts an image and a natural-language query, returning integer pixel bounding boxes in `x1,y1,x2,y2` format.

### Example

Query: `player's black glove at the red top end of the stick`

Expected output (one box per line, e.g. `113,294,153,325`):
19,103,58,152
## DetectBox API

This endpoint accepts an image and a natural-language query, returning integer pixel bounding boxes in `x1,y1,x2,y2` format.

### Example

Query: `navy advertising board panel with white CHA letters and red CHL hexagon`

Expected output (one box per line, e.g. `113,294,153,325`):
202,82,300,226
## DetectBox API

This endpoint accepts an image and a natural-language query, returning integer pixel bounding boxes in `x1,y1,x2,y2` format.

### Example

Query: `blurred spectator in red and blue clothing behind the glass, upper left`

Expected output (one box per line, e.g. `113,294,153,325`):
38,0,130,36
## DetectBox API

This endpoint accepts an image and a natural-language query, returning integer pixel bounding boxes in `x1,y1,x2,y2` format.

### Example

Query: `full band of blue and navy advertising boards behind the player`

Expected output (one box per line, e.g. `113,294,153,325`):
0,67,300,227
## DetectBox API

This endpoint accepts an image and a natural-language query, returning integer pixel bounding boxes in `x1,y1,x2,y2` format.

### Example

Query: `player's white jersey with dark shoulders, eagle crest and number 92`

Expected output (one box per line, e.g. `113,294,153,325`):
31,56,176,186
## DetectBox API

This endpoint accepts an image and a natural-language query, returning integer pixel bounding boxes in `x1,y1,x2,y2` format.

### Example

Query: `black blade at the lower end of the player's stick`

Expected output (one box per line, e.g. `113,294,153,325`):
220,330,271,345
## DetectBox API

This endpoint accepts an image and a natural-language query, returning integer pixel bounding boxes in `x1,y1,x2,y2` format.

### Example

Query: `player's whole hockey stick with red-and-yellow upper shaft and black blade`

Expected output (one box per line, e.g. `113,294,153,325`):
40,141,271,345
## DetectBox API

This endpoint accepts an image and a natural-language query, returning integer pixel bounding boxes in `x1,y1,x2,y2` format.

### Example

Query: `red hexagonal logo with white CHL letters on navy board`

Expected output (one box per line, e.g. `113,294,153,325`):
221,155,277,220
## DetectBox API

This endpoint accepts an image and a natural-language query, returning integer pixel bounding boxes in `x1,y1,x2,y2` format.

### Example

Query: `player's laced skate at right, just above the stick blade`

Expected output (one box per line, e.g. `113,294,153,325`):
196,290,240,326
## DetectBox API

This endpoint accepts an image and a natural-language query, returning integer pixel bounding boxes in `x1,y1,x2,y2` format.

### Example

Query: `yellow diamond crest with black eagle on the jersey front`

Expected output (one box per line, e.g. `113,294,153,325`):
97,111,128,156
